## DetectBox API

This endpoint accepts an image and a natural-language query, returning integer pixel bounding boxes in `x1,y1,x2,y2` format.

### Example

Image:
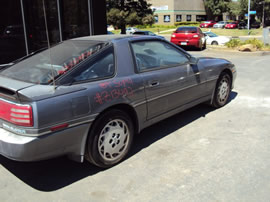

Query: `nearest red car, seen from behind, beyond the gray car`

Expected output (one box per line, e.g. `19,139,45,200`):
171,27,206,50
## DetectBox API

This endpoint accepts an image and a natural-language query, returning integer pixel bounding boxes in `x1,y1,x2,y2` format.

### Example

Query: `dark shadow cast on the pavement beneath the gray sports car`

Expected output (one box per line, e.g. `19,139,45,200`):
0,92,237,192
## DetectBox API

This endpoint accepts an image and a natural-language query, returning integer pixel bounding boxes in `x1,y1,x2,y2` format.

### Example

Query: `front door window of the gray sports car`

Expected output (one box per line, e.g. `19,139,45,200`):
131,41,189,72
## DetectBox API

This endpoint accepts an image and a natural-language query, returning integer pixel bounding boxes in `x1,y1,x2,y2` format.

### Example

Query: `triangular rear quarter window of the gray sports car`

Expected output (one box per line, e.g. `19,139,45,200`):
62,47,115,83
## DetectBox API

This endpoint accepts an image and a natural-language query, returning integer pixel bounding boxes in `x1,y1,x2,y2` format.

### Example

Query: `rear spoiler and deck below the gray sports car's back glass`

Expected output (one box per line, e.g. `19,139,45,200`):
0,76,85,102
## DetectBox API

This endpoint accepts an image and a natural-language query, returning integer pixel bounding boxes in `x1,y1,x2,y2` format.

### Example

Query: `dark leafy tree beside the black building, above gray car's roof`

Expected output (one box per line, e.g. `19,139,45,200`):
106,0,153,34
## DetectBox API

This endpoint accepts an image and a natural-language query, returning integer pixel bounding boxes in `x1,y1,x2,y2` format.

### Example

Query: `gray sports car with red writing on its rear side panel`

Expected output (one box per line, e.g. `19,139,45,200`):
0,35,236,167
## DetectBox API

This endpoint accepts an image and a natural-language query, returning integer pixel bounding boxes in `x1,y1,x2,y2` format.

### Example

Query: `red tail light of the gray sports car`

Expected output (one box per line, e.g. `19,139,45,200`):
0,100,33,127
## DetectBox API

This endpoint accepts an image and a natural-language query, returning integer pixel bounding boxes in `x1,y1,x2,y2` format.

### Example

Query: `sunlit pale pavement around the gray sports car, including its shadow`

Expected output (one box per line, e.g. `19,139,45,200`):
0,50,270,202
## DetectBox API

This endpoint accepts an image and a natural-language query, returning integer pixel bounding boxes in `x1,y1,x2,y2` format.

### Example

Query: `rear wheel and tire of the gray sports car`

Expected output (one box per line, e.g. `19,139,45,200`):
85,109,134,168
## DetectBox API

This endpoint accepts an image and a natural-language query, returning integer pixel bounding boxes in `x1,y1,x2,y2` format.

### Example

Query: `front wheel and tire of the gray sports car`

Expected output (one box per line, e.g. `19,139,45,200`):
212,72,232,108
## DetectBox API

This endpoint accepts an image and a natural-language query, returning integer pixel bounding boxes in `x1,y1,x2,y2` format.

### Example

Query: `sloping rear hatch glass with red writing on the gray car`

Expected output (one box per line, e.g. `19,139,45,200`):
0,40,105,84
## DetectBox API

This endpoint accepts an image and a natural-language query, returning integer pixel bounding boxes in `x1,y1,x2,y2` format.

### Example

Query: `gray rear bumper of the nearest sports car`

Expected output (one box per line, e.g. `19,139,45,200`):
0,124,90,161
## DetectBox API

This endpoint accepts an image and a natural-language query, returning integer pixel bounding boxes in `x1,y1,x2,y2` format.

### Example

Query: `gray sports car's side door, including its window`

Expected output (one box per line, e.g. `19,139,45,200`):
131,40,204,119
